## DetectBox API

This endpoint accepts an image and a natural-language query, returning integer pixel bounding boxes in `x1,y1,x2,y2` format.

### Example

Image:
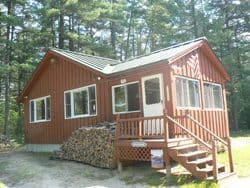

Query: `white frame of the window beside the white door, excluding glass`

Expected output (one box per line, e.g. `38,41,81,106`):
112,81,141,114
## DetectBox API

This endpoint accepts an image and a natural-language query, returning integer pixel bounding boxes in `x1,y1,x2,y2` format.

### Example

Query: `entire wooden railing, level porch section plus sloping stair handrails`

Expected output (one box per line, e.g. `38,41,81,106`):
116,111,234,179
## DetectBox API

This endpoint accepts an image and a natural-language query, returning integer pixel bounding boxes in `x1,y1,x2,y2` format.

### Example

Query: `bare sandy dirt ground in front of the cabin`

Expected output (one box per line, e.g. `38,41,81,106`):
0,149,250,188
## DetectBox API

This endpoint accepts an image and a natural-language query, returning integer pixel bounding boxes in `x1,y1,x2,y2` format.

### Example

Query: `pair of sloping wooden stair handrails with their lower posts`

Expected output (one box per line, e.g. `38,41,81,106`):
166,114,234,180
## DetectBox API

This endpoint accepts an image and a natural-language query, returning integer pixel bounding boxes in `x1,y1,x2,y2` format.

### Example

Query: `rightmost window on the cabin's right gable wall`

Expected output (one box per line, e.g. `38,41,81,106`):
204,83,223,109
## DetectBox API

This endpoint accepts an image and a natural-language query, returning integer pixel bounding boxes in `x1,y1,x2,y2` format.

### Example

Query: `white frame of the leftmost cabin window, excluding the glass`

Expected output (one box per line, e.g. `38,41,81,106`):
29,95,51,123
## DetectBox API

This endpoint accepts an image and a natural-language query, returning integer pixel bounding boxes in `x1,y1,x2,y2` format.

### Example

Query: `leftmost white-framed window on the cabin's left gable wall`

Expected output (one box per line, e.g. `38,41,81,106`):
30,96,51,122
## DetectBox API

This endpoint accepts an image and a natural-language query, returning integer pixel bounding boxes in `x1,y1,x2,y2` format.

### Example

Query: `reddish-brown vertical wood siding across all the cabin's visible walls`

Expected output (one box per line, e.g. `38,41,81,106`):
24,48,229,144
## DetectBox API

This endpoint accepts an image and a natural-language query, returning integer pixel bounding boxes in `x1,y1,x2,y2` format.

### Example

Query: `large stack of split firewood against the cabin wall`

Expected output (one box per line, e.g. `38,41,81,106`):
52,122,116,168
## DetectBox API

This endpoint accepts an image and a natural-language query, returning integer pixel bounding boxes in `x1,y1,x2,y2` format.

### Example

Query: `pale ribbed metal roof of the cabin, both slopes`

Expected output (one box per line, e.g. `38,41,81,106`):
50,37,207,75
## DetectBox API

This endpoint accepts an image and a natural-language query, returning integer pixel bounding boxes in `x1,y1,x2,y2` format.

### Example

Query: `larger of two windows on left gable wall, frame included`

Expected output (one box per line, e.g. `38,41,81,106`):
64,85,96,118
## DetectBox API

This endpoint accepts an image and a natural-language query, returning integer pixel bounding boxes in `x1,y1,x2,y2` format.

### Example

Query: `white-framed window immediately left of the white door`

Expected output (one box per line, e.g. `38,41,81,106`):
113,83,140,113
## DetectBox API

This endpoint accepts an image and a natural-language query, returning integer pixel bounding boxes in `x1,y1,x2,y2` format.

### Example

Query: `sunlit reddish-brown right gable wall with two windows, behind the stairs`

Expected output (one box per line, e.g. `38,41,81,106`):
170,49,229,140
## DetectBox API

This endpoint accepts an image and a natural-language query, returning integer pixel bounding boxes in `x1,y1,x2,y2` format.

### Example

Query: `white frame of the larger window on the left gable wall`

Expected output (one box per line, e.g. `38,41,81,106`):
64,84,97,119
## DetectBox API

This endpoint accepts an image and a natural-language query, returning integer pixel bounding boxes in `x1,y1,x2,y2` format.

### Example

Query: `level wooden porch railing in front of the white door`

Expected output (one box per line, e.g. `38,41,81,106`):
116,111,168,140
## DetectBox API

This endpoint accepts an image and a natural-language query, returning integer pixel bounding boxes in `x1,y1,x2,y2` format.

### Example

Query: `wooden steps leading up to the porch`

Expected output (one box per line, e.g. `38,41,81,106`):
168,140,232,181
